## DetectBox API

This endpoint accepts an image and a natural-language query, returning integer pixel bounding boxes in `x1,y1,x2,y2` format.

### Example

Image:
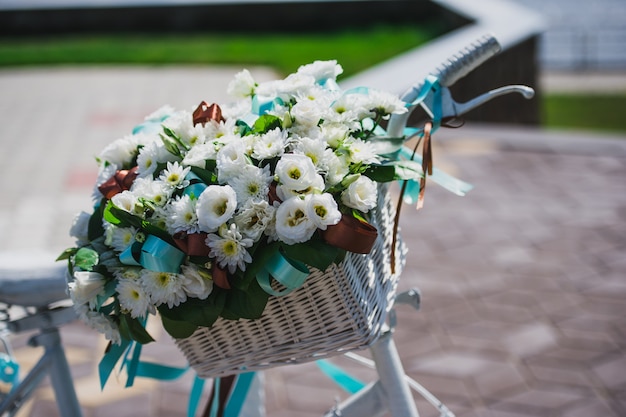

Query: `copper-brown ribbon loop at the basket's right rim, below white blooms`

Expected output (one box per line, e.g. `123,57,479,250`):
322,214,378,254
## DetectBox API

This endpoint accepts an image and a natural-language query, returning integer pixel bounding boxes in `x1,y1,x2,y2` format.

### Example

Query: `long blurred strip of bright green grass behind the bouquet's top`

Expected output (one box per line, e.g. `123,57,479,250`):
0,25,444,76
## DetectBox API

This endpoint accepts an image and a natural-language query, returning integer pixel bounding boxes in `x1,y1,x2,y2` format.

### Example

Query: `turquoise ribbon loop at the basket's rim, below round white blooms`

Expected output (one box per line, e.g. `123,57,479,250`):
256,247,310,296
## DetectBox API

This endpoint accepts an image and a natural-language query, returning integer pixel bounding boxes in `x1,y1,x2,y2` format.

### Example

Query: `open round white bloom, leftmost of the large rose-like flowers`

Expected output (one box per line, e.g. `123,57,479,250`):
196,185,237,232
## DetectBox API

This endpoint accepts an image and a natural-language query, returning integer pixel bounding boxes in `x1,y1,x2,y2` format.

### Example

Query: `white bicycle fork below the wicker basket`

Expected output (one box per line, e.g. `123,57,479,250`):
324,331,419,417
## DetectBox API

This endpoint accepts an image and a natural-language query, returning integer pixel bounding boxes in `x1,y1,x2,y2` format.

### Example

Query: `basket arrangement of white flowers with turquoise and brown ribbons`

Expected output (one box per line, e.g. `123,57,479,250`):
61,61,422,376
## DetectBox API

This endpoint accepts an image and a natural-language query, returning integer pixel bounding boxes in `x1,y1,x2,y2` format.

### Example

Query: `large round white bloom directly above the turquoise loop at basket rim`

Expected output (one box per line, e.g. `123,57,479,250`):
276,196,317,245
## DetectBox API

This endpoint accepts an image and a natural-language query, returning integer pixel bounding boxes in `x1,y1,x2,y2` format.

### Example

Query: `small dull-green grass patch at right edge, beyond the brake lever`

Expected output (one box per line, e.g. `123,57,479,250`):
542,93,626,133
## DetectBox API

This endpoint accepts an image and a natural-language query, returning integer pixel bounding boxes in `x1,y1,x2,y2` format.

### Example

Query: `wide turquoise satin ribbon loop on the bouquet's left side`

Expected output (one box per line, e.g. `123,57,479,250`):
119,235,185,274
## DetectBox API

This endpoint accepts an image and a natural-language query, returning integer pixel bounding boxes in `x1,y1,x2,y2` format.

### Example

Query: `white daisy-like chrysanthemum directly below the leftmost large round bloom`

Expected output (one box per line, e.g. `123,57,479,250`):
206,224,254,273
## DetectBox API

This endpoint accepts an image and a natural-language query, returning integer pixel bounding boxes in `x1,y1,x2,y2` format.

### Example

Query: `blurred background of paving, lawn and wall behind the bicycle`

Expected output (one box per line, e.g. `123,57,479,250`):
0,0,626,417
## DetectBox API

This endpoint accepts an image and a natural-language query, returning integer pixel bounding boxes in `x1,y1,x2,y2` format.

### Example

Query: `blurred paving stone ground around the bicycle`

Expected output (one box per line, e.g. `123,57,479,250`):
0,67,626,417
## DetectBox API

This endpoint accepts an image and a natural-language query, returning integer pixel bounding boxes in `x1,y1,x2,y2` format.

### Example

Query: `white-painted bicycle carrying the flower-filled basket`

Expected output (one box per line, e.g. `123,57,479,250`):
0,36,534,417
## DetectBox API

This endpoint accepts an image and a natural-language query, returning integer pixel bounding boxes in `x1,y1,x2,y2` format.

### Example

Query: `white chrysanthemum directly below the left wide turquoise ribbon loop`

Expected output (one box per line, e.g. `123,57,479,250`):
141,269,187,308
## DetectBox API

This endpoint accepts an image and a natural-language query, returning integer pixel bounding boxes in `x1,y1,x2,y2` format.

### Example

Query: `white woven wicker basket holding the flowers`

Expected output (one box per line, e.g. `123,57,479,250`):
176,185,406,378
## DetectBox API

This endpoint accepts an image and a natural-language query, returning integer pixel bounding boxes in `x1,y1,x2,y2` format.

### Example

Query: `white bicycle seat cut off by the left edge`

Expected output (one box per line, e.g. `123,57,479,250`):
0,251,68,307
